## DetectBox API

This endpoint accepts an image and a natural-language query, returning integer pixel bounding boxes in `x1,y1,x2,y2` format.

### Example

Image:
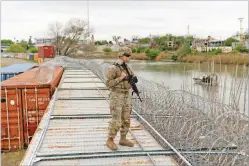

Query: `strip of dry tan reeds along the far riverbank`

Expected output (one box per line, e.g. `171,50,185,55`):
72,52,249,65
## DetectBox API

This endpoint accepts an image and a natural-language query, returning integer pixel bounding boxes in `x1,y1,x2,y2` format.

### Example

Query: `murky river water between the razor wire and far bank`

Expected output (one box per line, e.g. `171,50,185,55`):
102,60,248,114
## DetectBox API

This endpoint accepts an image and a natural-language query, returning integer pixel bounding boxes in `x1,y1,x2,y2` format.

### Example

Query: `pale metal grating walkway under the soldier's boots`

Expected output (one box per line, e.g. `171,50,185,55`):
20,68,190,166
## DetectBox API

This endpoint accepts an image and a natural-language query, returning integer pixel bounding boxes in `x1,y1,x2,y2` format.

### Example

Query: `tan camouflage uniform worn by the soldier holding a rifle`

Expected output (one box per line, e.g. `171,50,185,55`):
106,47,132,138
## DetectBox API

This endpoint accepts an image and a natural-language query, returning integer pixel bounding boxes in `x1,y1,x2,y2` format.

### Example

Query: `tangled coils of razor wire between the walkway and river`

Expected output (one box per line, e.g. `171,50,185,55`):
49,57,249,166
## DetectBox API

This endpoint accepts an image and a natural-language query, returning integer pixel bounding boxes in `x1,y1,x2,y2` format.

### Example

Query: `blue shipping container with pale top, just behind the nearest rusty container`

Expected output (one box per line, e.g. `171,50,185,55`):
0,63,36,81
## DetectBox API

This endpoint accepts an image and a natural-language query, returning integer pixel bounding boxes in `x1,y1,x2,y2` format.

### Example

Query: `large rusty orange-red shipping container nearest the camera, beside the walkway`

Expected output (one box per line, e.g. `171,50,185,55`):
1,66,63,151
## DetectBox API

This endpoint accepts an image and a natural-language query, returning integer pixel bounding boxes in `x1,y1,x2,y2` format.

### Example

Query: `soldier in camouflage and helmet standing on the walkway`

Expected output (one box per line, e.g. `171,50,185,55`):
106,47,134,150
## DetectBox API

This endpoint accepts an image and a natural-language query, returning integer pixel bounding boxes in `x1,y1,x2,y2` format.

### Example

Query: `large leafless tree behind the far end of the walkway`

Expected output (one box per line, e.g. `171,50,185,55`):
49,19,92,56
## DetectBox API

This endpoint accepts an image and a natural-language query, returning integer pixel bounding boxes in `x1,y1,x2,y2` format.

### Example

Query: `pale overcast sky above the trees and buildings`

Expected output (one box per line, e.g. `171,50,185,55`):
1,1,248,40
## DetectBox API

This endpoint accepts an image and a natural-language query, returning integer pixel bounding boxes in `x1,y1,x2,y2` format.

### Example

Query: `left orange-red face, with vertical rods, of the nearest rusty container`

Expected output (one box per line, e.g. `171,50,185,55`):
1,89,24,151
